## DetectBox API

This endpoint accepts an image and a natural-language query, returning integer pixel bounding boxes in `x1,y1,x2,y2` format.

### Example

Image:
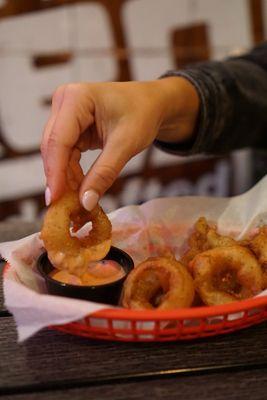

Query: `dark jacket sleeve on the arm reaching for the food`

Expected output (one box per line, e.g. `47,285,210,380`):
155,43,267,155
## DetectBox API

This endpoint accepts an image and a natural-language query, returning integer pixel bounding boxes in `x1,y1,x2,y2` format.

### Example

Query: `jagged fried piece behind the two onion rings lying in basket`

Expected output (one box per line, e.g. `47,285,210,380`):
181,217,238,267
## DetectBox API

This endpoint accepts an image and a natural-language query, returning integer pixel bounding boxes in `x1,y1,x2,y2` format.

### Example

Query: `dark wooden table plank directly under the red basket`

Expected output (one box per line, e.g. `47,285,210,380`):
0,317,267,392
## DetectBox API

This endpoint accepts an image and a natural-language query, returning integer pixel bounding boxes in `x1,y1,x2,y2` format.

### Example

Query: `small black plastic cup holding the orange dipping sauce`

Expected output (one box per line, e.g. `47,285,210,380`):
37,246,134,305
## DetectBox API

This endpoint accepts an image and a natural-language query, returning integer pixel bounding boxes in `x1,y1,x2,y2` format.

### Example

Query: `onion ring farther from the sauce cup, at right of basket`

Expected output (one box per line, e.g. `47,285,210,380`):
190,245,263,306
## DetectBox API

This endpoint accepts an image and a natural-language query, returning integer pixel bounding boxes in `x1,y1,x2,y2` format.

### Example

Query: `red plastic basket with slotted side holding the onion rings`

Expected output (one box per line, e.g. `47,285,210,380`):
5,264,267,342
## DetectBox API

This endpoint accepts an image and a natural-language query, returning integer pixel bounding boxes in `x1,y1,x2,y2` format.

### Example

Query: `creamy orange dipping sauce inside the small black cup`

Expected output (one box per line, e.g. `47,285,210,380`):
49,260,125,286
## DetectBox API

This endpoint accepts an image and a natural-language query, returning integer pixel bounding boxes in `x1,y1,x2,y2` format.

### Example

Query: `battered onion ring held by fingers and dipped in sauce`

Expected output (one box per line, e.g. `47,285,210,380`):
41,190,111,276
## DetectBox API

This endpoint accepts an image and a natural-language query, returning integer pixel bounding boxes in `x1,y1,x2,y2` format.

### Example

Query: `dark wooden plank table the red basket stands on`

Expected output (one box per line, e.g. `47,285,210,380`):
0,223,267,400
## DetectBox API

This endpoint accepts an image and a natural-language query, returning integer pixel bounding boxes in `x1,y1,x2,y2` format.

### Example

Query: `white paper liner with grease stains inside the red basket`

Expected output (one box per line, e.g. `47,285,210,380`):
0,176,267,341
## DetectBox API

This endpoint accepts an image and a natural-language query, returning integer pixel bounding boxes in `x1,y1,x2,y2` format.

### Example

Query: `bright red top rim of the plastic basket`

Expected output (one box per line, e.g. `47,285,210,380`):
3,262,267,321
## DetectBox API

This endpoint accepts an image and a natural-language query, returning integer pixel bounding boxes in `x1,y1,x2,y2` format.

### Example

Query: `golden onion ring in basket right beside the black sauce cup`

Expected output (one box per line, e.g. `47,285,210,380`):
122,257,195,310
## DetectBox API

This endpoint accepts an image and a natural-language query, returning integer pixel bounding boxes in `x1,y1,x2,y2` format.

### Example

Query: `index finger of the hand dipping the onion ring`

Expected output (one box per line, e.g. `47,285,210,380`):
41,84,94,201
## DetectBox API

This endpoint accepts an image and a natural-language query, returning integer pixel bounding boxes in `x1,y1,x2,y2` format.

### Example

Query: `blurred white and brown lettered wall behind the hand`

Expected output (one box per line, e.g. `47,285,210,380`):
0,0,267,221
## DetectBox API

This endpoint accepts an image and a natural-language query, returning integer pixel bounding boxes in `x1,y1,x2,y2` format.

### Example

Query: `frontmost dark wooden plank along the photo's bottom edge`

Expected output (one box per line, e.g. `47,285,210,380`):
2,369,267,400
